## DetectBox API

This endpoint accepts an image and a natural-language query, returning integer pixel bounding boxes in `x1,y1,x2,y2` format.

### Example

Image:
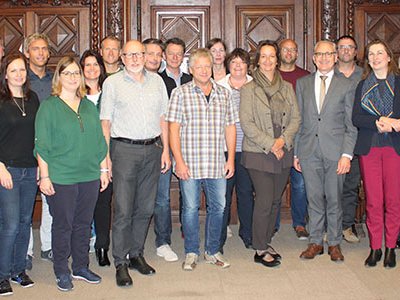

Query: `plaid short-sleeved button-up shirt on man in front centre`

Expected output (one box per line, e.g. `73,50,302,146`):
166,80,239,179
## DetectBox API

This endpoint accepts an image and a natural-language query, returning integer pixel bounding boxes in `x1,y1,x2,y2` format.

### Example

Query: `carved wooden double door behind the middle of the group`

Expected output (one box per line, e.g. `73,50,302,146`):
137,0,313,222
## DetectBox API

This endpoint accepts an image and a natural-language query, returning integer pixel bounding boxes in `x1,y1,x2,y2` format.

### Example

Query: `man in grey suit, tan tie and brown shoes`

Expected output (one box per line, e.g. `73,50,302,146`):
294,41,357,262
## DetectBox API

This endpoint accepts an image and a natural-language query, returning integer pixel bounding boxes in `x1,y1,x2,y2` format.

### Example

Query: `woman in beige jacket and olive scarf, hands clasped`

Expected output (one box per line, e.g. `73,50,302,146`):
239,40,300,267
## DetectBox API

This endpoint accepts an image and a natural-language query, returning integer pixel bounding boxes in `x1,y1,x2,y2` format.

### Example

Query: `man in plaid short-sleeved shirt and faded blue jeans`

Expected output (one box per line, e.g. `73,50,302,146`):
166,49,238,271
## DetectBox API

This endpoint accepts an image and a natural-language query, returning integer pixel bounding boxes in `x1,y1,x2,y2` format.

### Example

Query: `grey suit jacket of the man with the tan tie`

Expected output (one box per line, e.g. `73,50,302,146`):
295,73,357,161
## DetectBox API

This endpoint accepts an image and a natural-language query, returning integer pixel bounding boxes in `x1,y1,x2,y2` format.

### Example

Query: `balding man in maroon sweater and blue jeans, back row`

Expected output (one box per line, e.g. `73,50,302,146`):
275,39,310,240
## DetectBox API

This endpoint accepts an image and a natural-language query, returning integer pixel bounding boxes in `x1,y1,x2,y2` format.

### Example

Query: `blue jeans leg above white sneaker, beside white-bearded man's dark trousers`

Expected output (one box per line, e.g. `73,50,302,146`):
154,169,172,247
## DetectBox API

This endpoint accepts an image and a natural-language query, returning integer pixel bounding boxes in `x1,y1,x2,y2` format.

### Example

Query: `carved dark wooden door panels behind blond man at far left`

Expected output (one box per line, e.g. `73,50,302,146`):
0,1,91,67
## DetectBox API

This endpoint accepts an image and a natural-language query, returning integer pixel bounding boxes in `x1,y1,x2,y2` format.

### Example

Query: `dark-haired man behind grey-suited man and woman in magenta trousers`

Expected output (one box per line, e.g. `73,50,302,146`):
335,35,365,243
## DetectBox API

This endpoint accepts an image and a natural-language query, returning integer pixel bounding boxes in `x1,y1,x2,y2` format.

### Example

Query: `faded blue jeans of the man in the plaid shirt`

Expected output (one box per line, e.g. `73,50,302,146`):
180,178,226,255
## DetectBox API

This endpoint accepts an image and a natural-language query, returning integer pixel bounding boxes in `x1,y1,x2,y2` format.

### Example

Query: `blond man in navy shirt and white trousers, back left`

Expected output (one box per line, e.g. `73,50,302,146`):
24,33,53,270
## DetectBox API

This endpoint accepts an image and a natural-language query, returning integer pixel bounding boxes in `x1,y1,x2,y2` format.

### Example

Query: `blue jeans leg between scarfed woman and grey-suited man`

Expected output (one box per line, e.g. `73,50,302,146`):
290,168,307,227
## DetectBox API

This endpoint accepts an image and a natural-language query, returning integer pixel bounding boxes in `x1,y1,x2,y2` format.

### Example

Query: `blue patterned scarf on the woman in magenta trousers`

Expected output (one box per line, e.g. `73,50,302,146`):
361,72,395,117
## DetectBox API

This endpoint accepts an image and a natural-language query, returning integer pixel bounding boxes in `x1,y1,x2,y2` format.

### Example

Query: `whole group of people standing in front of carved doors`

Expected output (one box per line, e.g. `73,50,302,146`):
0,29,400,295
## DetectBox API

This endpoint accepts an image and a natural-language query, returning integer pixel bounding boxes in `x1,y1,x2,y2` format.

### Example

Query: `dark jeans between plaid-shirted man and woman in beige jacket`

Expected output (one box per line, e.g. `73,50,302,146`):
220,152,254,250
